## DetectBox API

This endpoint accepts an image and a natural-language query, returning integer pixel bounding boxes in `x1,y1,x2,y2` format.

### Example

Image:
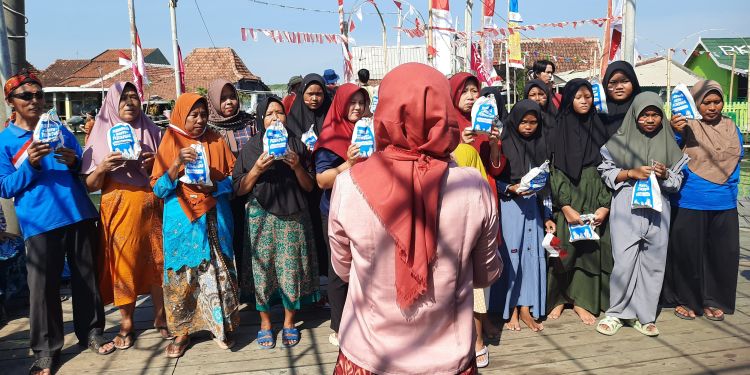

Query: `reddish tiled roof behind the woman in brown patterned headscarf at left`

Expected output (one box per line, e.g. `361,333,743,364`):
185,48,260,91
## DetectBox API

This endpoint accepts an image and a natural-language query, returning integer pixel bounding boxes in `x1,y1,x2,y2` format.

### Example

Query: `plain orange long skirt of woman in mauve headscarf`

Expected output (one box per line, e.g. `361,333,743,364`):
98,179,164,306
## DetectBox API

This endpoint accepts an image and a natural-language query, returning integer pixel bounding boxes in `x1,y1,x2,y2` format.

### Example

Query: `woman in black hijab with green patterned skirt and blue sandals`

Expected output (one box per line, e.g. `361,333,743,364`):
233,96,319,349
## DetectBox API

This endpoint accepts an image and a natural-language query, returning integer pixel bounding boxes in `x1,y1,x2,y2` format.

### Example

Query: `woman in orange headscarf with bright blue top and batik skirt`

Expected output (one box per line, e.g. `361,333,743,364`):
151,93,239,358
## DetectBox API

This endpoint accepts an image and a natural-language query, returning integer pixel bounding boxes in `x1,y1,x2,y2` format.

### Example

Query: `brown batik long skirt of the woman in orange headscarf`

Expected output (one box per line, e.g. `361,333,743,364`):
164,208,239,341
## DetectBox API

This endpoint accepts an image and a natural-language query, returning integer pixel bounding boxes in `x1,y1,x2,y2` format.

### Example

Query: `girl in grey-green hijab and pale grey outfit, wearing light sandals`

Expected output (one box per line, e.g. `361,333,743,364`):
596,92,687,336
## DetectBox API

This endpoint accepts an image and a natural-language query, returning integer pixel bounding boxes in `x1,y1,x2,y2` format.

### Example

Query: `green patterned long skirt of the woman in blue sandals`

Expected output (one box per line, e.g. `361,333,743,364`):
241,198,320,311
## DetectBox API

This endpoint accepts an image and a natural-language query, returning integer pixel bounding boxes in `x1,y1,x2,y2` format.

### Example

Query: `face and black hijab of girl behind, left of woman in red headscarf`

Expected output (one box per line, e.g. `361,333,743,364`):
287,73,331,138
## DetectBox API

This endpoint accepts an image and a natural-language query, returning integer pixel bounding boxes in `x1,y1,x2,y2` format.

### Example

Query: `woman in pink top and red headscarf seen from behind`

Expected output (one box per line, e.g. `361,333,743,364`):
328,63,501,374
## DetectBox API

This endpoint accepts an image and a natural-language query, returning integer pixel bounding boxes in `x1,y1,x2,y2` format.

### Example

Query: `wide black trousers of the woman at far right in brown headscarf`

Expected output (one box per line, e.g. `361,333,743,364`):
661,207,740,315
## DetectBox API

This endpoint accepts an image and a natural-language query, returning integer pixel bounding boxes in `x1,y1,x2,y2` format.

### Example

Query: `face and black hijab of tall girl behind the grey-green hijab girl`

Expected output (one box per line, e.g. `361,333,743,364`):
599,61,641,137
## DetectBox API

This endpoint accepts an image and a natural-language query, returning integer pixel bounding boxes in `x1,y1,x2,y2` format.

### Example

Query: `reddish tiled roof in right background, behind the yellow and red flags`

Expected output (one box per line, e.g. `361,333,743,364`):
494,37,600,72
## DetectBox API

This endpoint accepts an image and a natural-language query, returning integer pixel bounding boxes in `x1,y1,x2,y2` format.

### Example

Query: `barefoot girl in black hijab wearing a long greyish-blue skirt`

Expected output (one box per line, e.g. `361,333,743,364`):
497,99,555,332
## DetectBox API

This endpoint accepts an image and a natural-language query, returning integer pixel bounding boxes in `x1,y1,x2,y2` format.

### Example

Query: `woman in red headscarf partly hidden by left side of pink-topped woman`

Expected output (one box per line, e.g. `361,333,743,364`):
313,83,370,345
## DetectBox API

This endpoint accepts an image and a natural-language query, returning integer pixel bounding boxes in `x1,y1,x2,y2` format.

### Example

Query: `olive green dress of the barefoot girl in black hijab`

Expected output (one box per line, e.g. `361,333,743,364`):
547,165,614,315
